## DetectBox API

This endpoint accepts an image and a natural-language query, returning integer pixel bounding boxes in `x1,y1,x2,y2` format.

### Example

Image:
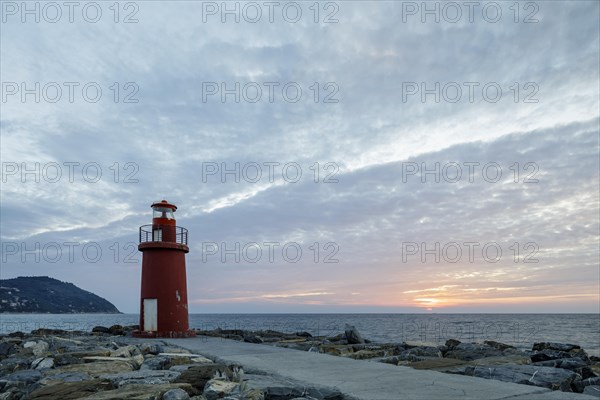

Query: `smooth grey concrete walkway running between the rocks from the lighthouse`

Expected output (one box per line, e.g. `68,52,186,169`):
166,336,597,400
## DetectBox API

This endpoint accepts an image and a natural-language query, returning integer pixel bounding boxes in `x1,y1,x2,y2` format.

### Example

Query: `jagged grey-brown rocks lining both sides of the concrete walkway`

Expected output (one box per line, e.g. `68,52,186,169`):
0,325,600,400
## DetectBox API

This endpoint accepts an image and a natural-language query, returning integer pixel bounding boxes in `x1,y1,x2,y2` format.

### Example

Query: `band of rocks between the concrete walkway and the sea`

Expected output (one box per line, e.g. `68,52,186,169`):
198,326,600,398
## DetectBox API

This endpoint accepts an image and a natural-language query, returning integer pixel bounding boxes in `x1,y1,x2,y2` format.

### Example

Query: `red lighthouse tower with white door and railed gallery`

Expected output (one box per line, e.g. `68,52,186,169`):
134,200,195,337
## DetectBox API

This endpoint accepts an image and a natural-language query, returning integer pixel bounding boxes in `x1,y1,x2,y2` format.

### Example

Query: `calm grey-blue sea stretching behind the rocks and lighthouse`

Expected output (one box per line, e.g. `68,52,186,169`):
0,314,600,356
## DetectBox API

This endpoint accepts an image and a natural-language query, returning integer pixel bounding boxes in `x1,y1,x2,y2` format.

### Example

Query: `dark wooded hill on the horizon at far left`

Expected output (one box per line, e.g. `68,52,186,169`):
0,276,119,314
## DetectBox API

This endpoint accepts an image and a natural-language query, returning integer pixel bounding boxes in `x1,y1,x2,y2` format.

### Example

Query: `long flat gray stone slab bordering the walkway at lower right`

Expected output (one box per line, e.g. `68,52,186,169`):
465,365,577,392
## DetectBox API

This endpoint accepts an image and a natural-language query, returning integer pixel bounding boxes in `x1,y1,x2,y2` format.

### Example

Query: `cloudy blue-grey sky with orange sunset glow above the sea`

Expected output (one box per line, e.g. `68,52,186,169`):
0,1,600,312
